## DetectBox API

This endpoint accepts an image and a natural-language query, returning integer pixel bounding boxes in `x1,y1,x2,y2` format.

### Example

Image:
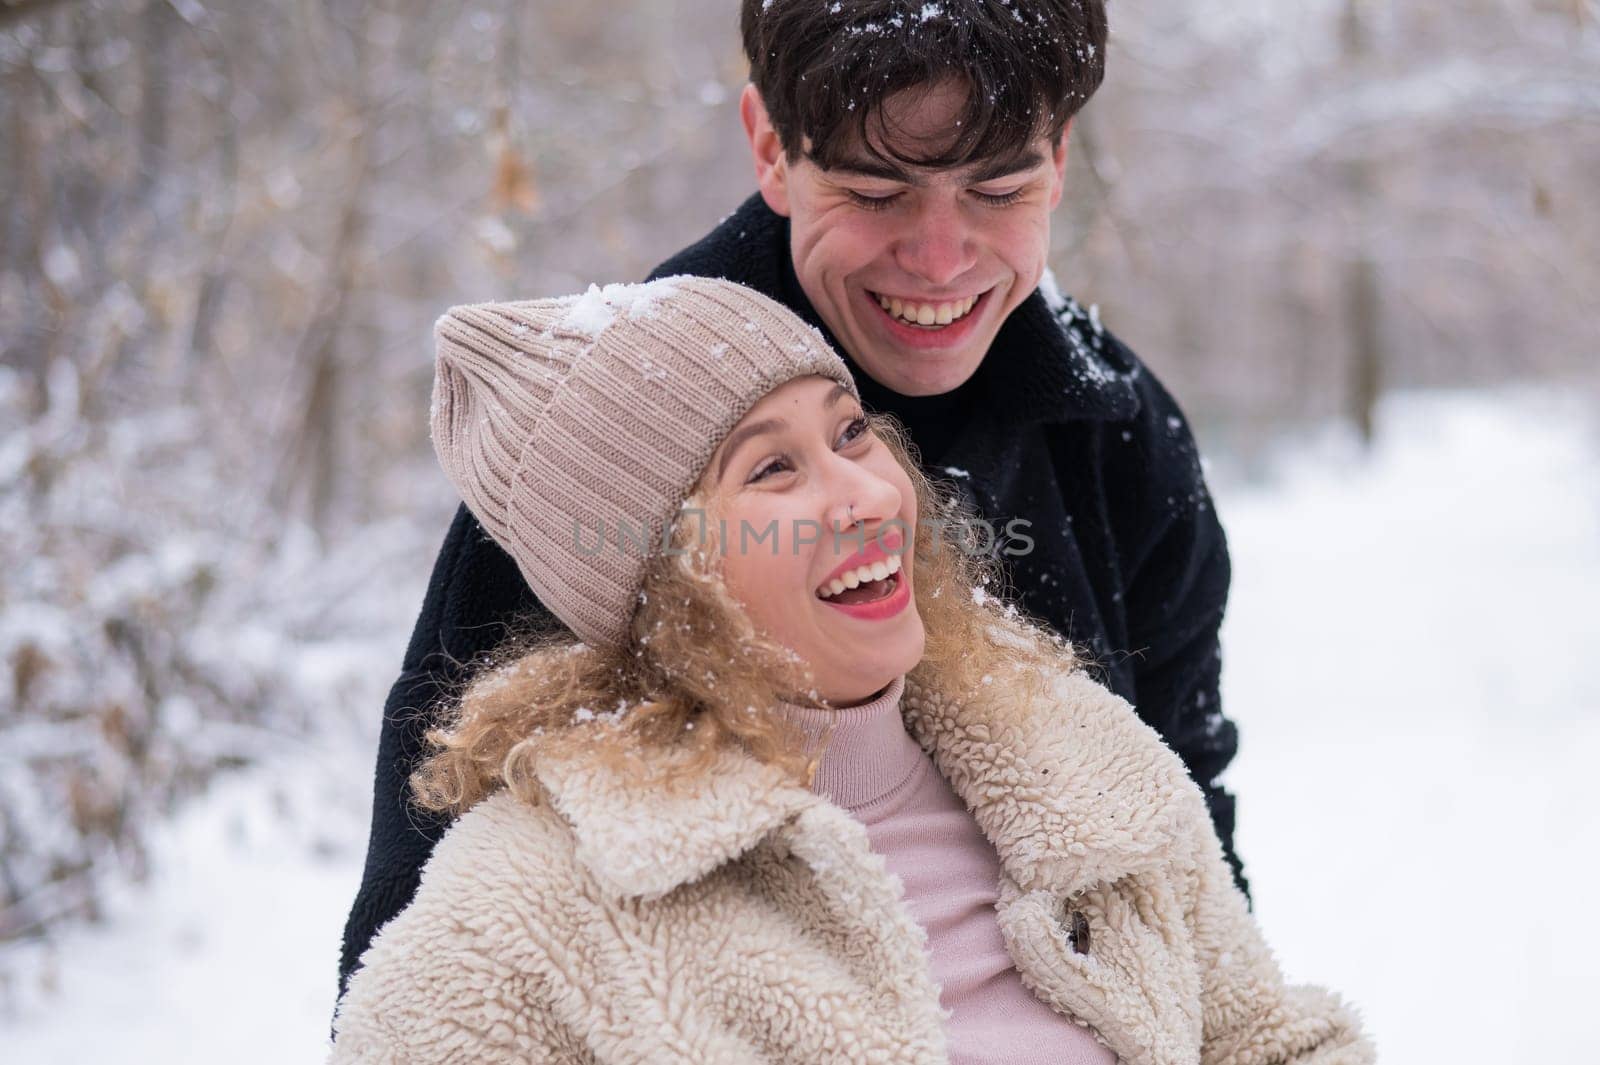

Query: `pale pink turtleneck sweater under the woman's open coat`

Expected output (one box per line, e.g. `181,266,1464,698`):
781,678,1117,1065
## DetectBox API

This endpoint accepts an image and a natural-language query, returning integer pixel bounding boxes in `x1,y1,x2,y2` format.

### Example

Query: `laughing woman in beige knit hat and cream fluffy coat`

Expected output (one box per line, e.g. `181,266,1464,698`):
333,277,1371,1065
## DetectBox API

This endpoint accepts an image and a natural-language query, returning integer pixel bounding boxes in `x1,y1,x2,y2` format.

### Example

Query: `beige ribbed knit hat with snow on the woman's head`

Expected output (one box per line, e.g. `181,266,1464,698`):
430,277,859,646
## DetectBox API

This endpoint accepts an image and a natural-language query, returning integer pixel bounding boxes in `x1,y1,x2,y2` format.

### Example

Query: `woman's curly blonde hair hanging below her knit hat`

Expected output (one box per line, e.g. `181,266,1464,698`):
411,414,1077,814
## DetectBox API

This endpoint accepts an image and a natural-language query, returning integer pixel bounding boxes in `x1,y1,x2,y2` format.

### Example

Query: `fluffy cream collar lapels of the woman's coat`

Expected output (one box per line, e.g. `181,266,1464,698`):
536,673,1200,899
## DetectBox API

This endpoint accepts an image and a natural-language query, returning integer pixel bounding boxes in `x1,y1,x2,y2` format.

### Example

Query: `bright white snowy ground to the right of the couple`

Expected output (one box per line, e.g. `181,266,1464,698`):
1219,392,1600,1063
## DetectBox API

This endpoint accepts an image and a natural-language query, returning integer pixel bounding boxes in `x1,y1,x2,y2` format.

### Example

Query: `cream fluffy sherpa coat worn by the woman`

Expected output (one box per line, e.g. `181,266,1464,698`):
333,673,1373,1065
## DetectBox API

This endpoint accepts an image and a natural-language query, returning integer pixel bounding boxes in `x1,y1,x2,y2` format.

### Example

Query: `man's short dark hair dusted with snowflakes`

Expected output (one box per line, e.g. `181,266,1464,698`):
739,0,1106,170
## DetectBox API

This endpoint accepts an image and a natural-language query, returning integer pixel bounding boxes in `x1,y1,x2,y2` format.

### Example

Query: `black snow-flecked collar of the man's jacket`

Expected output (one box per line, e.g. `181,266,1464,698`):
651,193,1142,424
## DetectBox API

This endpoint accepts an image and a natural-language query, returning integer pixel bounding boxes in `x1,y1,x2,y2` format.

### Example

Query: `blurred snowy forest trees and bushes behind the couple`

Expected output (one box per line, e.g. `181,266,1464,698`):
0,0,1600,977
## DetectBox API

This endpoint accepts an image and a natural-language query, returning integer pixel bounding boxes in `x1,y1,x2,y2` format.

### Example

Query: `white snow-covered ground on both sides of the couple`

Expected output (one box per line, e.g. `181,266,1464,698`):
0,392,1600,1065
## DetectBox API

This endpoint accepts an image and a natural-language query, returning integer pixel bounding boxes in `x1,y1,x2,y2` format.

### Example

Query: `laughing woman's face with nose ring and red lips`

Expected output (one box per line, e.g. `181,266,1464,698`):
699,376,923,705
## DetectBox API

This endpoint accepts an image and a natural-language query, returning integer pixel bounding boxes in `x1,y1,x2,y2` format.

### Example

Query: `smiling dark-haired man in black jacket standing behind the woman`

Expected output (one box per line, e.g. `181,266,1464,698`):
341,0,1243,993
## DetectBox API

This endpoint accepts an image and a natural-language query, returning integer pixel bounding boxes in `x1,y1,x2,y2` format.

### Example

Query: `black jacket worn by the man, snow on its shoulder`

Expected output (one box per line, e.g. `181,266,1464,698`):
339,195,1245,995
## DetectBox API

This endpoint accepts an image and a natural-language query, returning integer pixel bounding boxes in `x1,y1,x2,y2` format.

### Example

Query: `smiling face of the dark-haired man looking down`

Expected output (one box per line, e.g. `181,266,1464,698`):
741,82,1067,395
